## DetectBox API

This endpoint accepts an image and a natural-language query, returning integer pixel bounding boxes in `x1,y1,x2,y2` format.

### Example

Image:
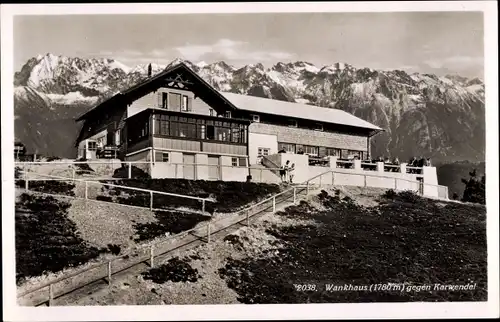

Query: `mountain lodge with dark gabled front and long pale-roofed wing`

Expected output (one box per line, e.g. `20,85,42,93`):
76,64,382,181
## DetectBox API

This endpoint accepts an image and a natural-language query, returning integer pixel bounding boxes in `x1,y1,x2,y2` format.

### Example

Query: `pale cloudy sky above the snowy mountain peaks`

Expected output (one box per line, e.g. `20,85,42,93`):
14,12,484,78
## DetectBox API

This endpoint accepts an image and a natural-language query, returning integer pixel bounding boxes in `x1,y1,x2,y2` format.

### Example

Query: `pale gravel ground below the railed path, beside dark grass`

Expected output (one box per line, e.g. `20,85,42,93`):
68,203,312,305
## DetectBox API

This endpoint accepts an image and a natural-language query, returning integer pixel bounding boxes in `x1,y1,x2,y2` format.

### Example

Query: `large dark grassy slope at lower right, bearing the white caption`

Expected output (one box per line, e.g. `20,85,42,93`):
221,189,487,303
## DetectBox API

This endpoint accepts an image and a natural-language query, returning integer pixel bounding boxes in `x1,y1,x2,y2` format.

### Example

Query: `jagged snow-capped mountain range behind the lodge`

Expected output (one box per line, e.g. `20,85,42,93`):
14,54,485,161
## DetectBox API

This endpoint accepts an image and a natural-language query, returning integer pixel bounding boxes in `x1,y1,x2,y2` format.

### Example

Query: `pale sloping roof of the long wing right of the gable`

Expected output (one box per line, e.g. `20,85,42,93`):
220,92,382,131
